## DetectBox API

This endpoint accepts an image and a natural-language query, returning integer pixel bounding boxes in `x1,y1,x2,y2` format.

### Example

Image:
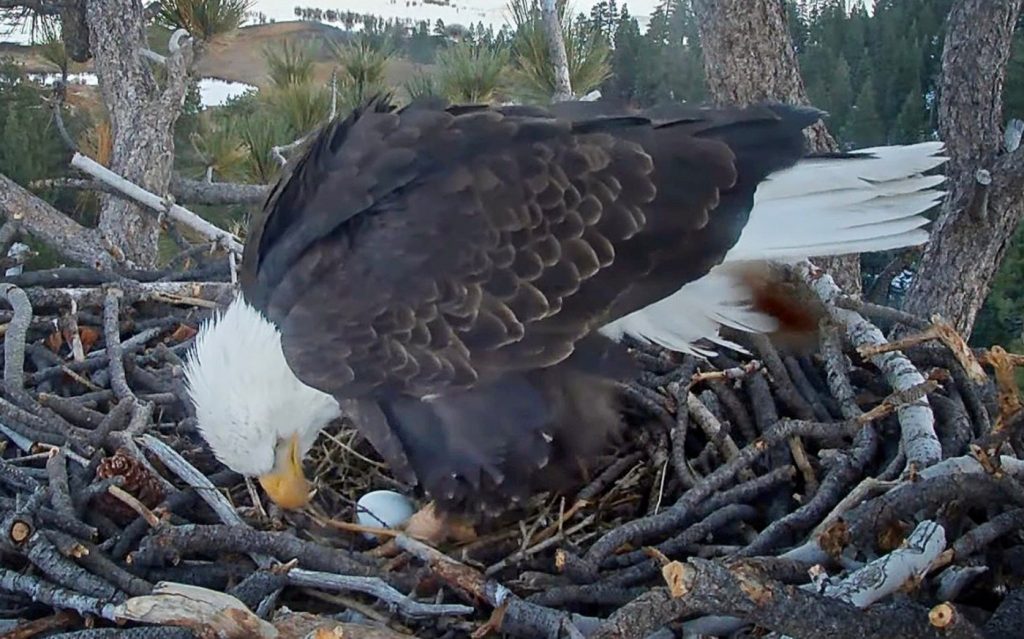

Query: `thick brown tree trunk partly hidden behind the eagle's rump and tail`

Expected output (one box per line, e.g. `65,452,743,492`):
693,0,861,295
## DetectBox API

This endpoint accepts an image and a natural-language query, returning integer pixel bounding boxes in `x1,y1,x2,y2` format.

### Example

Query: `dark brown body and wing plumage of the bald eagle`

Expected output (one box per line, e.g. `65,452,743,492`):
243,93,817,508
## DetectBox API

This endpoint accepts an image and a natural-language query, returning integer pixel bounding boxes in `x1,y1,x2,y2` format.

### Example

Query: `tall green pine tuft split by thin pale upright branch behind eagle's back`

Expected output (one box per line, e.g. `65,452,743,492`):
508,0,611,103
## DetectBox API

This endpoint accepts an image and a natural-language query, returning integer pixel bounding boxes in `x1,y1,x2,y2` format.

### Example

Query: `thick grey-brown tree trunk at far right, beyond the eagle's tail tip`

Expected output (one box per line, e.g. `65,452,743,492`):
904,0,1024,336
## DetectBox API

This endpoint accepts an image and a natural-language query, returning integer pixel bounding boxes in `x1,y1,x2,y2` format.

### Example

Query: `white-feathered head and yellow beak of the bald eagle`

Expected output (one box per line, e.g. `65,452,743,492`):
184,295,341,508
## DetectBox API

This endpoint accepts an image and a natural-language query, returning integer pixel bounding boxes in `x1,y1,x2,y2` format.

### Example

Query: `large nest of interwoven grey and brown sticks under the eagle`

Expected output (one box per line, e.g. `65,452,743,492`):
0,266,1024,639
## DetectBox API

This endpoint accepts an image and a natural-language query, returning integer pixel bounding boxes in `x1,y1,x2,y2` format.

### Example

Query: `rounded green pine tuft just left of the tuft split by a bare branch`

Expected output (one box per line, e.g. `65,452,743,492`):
437,42,508,103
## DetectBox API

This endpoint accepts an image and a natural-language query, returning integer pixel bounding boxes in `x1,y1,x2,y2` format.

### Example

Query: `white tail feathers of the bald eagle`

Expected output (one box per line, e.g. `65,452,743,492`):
601,142,946,355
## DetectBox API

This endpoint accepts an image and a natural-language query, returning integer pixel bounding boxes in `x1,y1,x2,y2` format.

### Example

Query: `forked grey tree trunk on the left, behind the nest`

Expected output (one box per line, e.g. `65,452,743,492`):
87,0,193,268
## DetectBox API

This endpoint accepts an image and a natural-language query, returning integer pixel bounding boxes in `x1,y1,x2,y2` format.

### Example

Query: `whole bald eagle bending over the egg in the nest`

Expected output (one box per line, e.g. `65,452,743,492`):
185,97,944,520
